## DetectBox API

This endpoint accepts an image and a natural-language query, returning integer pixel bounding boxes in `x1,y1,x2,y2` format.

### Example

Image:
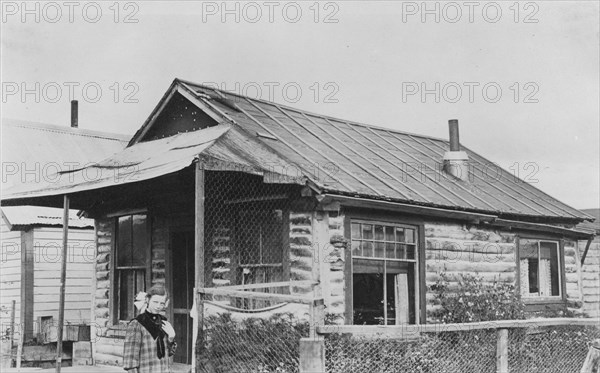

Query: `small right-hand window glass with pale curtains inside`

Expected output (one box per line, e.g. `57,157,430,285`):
519,239,561,298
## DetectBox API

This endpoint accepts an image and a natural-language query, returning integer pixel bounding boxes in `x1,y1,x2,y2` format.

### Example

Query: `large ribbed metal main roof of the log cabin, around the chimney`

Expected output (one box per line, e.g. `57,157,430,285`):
176,82,590,219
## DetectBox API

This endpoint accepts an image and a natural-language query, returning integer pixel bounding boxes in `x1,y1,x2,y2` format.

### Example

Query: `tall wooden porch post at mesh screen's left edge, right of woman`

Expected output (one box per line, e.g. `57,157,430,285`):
197,160,205,372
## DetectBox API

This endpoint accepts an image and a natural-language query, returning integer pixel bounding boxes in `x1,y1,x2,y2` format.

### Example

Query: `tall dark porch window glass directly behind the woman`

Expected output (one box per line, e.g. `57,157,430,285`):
115,214,150,320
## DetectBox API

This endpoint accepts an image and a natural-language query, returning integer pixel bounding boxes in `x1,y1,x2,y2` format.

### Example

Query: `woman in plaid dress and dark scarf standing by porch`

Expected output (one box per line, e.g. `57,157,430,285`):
123,285,177,373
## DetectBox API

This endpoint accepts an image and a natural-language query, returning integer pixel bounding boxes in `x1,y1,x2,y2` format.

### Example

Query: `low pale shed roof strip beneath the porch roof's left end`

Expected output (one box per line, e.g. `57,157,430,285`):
2,206,94,228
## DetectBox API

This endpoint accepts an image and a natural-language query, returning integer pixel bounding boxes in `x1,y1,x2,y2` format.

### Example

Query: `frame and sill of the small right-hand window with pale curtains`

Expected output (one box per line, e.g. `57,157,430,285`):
515,233,567,311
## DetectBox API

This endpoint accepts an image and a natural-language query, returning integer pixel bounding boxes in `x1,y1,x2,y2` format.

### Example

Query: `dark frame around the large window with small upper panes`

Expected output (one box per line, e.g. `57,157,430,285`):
344,208,427,325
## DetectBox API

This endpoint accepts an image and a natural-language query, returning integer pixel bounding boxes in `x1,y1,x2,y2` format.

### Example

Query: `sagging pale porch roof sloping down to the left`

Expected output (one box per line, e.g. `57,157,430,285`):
2,123,304,205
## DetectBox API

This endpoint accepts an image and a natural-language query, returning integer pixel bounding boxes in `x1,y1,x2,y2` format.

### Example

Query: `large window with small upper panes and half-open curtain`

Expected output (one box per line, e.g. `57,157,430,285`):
351,220,418,325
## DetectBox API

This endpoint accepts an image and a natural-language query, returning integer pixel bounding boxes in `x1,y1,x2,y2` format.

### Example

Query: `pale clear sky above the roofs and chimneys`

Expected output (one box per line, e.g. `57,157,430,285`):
0,1,600,209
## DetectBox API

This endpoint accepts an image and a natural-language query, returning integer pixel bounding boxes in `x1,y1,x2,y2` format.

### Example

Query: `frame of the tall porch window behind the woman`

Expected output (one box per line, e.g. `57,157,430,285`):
109,210,152,325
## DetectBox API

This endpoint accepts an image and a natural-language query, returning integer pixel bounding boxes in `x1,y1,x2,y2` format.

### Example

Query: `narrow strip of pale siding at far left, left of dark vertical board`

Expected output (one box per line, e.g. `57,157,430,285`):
0,216,21,335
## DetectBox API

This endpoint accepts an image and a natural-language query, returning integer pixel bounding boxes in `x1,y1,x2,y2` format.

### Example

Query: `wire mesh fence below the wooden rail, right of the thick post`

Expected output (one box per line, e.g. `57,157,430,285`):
325,324,600,373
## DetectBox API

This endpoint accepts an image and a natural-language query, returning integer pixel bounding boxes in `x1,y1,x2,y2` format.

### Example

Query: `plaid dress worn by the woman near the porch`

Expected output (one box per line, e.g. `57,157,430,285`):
123,319,177,373
